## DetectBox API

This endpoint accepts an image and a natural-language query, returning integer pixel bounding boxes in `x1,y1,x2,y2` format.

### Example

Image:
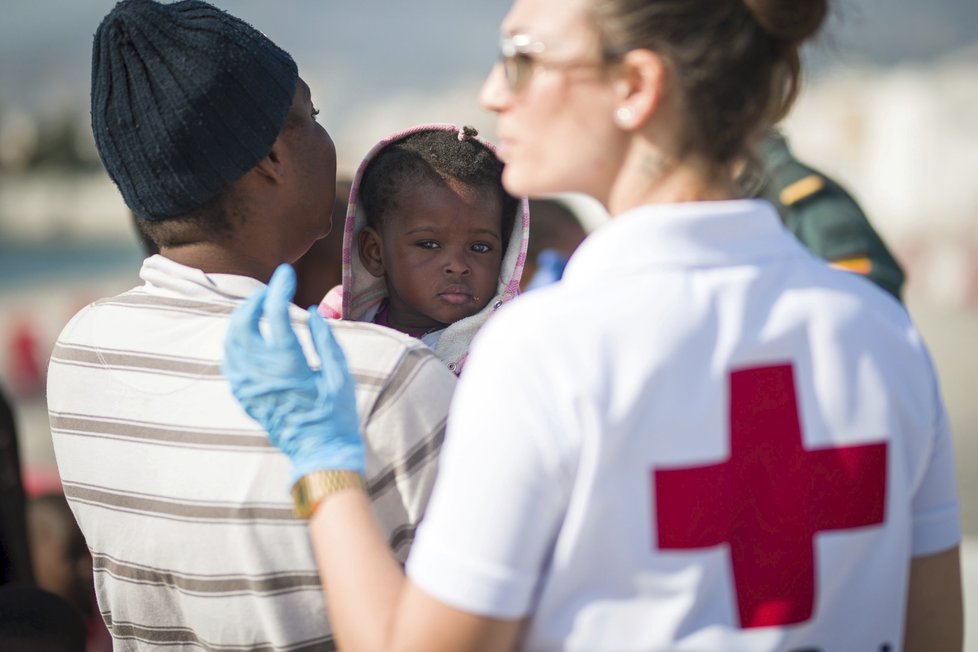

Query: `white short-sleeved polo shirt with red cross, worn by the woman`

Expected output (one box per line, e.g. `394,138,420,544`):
408,201,960,652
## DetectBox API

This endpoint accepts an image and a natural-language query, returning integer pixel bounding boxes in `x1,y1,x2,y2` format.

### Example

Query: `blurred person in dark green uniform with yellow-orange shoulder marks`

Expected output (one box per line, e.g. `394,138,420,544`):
753,130,904,299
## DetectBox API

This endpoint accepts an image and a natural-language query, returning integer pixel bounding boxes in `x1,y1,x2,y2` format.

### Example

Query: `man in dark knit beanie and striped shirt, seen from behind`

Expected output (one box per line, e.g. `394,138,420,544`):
48,0,455,650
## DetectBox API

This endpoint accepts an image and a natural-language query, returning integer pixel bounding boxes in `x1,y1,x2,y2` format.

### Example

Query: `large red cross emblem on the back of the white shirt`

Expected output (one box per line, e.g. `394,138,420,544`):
652,364,886,629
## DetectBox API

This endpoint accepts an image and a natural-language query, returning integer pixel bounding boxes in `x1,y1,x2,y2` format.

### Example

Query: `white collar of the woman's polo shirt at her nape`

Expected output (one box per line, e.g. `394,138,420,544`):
564,199,801,280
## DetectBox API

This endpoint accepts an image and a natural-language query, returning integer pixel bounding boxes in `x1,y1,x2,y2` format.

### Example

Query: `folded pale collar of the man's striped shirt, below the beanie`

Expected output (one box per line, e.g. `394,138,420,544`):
139,254,265,301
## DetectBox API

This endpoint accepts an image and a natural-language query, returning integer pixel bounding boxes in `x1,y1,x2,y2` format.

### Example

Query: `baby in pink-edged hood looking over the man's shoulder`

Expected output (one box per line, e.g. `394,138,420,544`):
319,124,529,374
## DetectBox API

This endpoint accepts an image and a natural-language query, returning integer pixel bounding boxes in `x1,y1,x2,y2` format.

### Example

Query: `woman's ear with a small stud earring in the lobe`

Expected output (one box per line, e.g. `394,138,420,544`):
615,49,666,131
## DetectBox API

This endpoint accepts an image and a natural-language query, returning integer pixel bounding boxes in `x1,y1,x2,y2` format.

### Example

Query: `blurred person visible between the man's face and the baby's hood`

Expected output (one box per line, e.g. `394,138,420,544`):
293,173,353,308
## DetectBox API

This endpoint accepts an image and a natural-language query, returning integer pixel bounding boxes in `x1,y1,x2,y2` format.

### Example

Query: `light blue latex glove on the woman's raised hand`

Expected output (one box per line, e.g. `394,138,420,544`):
222,265,364,484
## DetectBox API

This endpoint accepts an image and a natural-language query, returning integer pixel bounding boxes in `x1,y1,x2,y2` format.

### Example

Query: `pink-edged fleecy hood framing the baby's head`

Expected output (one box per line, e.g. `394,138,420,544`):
319,124,530,374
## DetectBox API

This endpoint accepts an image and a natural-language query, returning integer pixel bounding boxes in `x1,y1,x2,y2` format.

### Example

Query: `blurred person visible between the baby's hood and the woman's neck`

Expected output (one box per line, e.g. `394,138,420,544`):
520,197,587,292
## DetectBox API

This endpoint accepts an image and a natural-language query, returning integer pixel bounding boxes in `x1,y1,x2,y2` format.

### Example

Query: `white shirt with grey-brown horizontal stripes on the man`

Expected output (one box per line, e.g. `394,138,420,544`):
48,256,455,652
